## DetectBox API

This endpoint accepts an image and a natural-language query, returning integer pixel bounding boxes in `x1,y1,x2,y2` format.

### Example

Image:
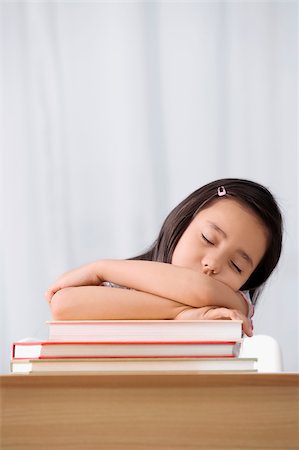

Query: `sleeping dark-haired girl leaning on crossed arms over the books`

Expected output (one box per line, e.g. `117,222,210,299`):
46,179,282,336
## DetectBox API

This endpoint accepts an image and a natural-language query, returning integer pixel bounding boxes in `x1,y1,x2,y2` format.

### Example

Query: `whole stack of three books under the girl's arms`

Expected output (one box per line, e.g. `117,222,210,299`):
11,320,256,373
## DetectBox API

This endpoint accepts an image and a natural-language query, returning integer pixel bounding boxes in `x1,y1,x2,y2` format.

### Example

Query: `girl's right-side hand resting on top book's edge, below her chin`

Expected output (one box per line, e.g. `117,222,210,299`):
174,306,253,336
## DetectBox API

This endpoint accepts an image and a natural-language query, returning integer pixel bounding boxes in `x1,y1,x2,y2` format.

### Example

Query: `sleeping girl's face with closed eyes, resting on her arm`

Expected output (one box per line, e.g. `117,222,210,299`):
171,198,267,291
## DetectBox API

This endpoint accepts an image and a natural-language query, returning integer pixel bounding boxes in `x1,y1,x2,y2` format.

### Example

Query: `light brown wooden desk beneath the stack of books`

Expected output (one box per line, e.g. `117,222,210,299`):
0,374,299,450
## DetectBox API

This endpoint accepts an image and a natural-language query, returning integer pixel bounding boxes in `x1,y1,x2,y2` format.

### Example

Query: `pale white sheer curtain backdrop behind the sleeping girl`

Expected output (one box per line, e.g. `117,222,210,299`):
0,1,299,373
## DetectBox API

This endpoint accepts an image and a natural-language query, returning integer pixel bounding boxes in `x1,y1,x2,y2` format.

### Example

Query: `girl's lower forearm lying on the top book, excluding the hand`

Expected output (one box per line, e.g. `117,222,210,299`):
50,286,186,320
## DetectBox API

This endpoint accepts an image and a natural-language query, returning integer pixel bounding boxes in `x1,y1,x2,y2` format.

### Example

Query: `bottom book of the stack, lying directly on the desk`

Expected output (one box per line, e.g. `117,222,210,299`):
11,358,256,374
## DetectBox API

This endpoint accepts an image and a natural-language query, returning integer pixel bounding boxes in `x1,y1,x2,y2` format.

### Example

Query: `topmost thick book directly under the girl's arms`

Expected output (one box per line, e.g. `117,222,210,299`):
48,320,242,342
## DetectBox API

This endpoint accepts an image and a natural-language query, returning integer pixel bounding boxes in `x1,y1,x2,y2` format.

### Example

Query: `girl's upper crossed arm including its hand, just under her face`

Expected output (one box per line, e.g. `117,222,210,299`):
46,260,247,315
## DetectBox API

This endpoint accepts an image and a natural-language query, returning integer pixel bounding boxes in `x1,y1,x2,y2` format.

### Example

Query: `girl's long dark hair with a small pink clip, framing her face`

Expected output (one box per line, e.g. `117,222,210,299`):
130,178,283,303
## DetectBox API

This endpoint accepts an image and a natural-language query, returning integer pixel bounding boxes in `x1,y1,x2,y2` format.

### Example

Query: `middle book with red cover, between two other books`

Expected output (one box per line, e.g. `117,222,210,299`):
12,341,240,359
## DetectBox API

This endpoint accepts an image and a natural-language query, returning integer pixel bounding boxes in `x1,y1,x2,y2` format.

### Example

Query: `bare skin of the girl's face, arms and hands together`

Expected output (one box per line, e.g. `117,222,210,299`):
46,199,267,335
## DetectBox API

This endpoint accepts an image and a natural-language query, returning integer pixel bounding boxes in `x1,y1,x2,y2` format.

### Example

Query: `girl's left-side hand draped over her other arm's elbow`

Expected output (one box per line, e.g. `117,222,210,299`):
45,263,104,303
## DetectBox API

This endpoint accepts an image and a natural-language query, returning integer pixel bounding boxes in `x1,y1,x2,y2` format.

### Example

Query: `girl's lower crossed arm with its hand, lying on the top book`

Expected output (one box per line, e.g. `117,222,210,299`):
50,286,252,336
